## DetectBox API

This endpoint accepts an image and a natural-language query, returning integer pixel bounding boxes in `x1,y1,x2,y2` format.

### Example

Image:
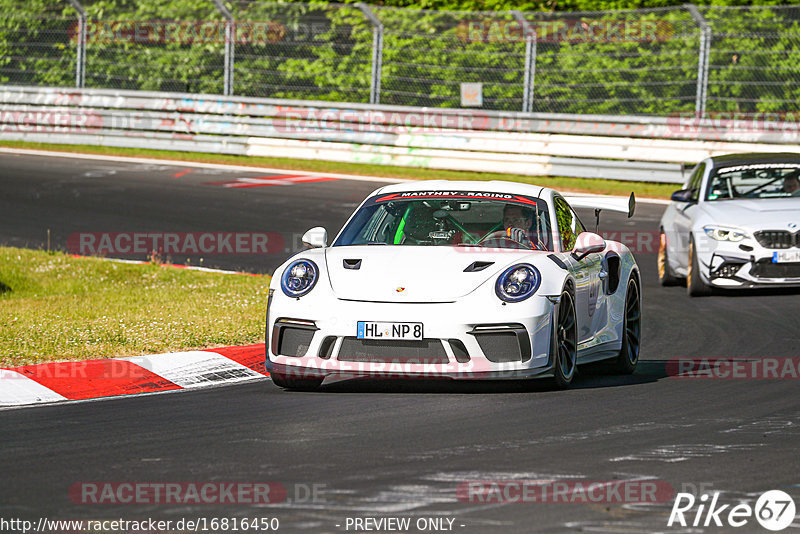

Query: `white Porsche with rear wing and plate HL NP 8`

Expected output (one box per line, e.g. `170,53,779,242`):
266,181,641,389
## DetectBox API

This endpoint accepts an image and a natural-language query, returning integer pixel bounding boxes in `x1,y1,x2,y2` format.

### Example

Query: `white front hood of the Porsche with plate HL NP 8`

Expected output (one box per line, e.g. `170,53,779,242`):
325,245,542,302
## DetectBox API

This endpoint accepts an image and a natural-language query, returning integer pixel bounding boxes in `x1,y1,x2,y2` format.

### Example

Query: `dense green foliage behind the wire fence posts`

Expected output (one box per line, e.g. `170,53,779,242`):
0,0,800,114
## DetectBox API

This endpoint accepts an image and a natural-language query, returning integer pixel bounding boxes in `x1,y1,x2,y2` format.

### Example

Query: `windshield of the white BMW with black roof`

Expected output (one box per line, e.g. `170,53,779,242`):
706,163,800,200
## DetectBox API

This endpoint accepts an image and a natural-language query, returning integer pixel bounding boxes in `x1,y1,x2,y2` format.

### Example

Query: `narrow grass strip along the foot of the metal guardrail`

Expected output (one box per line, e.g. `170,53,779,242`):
0,141,678,198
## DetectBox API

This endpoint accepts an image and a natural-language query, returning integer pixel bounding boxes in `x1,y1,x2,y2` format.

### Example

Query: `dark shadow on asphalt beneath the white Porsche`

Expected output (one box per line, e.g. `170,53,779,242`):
310,360,669,395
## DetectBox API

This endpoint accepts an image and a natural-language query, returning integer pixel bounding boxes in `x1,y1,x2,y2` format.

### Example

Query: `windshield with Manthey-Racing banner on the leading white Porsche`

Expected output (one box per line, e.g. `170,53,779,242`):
333,192,552,250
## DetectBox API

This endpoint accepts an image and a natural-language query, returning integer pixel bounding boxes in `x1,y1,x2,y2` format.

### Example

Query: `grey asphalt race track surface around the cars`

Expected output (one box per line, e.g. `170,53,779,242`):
0,155,800,533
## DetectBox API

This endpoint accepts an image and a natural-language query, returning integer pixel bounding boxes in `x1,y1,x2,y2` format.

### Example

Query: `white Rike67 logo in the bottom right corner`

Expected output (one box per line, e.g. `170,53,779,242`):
667,490,796,532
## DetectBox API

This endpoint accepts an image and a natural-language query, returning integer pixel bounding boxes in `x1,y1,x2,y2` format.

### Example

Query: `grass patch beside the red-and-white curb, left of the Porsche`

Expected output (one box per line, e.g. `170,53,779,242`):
0,247,269,367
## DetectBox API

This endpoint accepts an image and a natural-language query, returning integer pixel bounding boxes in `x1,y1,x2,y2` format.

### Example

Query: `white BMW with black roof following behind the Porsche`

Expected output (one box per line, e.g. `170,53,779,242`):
658,153,800,296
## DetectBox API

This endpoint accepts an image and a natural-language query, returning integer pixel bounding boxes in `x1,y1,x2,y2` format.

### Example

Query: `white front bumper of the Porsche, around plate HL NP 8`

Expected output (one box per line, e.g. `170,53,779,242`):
266,294,556,379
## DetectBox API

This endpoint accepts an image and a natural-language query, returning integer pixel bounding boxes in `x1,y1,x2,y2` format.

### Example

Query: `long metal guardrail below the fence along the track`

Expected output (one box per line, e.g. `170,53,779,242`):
0,86,800,183
